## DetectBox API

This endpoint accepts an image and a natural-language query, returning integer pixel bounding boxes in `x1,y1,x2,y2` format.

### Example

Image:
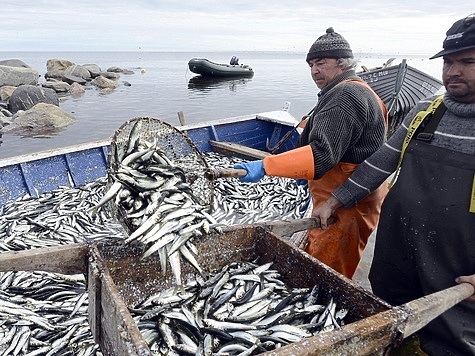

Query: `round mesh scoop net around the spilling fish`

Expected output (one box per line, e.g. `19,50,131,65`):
108,117,213,233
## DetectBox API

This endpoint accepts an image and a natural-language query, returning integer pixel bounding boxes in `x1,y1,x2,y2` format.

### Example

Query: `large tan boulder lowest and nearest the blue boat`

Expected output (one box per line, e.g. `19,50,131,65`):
3,103,76,135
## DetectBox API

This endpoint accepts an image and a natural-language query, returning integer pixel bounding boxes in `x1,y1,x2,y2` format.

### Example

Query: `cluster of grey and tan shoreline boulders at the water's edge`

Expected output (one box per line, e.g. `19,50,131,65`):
0,59,133,137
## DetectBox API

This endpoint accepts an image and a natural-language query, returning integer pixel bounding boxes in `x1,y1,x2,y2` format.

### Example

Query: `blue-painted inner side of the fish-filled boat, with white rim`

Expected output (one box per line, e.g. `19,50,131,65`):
0,111,297,206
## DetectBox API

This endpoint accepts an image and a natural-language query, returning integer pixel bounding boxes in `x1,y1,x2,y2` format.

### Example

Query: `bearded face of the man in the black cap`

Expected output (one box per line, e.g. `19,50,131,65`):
442,49,475,103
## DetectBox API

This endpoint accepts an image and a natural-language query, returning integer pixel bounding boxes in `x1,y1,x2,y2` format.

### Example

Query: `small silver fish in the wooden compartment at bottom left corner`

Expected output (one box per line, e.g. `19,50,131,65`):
0,271,102,356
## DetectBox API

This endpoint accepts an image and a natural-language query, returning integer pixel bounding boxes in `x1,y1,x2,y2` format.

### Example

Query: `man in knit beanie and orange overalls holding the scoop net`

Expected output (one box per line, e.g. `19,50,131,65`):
235,28,387,278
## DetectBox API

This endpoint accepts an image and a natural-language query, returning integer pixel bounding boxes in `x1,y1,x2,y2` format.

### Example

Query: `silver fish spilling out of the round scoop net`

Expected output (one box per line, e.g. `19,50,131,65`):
93,140,217,285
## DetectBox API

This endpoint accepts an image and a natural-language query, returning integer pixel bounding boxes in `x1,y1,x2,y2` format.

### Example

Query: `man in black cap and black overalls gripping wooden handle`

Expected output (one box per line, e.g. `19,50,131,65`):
314,14,475,355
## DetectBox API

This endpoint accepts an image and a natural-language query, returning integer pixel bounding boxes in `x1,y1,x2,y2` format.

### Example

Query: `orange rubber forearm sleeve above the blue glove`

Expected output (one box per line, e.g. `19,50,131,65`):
263,145,315,179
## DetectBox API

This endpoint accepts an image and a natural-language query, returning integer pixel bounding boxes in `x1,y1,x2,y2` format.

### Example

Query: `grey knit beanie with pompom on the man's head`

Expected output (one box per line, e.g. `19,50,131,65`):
307,27,353,62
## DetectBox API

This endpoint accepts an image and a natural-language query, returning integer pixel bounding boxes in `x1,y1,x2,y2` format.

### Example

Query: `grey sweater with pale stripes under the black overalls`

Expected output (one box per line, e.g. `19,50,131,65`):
333,93,475,207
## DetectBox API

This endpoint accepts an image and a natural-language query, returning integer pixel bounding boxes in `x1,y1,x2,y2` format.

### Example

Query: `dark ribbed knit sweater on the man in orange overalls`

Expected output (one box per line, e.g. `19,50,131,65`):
299,70,386,179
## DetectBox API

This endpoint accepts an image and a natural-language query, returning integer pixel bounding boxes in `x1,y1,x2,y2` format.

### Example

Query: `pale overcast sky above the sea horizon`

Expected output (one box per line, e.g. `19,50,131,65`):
0,0,475,54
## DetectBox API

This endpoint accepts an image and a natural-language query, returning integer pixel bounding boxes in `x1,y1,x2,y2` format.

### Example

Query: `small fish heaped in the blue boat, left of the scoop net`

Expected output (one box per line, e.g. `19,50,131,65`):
0,178,124,252
